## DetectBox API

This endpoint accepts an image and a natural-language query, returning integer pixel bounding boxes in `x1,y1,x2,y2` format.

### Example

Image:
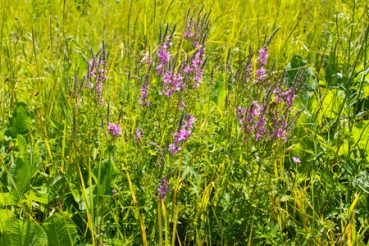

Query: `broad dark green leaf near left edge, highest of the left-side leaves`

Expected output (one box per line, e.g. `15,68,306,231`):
8,103,32,137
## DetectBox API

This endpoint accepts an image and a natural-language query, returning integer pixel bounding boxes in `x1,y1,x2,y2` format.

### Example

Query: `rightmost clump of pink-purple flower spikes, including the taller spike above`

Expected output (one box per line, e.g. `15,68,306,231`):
236,47,304,141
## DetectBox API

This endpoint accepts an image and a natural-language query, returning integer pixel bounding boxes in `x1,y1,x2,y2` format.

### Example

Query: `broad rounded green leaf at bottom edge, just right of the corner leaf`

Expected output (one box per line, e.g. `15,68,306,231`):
42,213,78,246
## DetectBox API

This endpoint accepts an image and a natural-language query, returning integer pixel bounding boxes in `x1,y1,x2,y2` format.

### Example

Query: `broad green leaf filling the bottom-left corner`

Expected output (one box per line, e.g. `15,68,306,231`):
0,218,48,246
